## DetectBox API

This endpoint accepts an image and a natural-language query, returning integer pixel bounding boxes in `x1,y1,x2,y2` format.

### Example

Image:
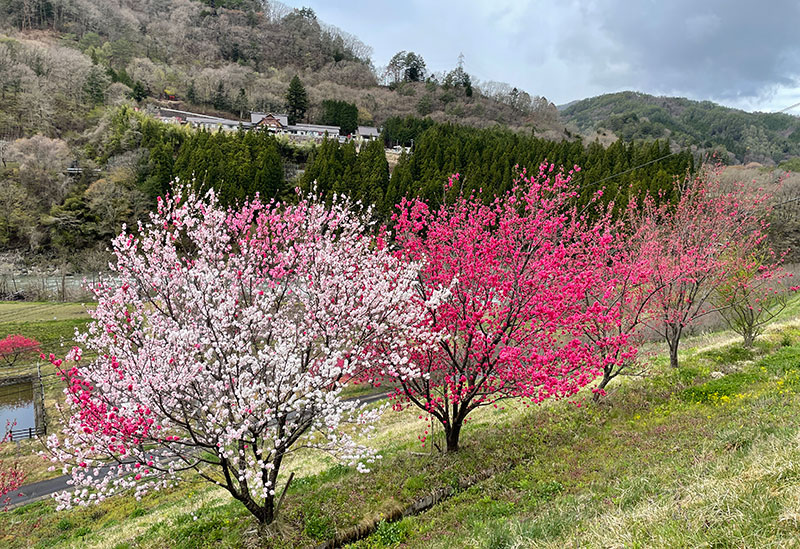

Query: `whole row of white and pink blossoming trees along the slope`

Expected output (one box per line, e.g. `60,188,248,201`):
39,164,788,524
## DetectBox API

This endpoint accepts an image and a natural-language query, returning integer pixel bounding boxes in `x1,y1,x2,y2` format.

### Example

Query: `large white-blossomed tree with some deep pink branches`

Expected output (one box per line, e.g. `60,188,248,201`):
48,192,428,524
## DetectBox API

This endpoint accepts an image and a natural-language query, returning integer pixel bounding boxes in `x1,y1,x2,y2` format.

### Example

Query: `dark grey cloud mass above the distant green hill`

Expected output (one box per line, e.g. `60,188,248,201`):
559,0,800,99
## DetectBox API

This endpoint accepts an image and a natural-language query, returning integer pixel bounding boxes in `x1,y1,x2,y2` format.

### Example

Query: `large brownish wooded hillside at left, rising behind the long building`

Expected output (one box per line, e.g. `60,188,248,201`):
0,0,568,270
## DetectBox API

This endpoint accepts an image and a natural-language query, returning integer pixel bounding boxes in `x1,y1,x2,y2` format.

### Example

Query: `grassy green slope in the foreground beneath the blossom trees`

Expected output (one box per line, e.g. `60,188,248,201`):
0,308,800,547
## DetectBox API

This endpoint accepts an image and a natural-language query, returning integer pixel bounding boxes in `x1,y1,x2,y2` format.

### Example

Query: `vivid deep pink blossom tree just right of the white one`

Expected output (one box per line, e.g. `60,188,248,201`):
387,165,626,452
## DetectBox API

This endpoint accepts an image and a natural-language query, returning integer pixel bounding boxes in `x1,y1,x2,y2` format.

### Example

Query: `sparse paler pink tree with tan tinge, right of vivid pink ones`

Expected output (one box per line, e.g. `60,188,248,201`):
632,166,770,367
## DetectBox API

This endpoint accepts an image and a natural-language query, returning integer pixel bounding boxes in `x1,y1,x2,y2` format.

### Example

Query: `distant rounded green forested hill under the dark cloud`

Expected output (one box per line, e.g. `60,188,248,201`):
561,91,800,164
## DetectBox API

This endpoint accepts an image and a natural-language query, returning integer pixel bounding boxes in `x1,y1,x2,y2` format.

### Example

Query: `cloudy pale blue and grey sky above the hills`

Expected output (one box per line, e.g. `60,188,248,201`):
287,0,800,115
